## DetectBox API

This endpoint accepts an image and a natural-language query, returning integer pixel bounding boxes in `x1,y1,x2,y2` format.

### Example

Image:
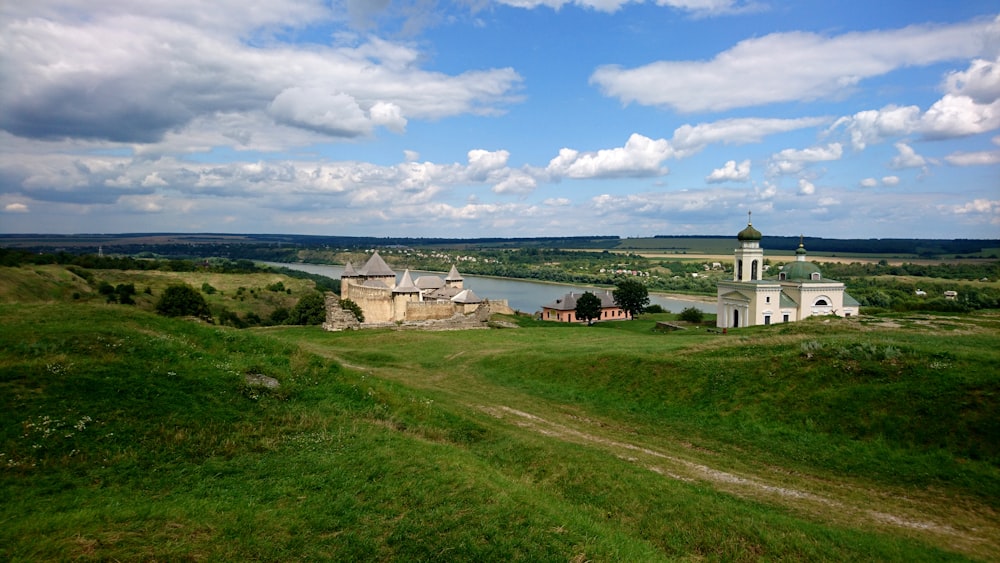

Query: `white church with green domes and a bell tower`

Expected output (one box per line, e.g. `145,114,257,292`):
716,216,860,328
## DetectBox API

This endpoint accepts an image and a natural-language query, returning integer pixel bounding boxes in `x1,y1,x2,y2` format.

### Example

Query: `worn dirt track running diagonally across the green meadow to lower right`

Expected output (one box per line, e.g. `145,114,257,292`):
294,340,1000,561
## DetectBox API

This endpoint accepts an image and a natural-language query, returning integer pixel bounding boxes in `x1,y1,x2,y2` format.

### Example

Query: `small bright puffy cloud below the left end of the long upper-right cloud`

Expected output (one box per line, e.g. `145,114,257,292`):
546,133,674,179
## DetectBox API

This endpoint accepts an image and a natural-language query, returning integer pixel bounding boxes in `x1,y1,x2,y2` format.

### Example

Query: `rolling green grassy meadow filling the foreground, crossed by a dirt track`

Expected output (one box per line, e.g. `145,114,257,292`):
0,267,1000,561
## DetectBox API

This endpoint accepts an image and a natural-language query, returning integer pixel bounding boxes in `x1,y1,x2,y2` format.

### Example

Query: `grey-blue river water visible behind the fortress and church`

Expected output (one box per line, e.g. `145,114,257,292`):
264,262,715,313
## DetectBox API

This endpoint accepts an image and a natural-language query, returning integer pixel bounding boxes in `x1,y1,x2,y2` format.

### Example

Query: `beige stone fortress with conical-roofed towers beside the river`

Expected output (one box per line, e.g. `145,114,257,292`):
323,251,512,331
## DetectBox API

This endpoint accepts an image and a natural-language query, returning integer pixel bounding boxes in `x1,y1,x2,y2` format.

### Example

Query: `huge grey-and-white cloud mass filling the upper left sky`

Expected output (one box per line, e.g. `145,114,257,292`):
0,6,521,143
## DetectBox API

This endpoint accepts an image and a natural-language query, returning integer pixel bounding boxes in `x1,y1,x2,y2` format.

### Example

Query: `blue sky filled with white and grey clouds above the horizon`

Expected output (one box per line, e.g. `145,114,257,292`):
0,0,1000,239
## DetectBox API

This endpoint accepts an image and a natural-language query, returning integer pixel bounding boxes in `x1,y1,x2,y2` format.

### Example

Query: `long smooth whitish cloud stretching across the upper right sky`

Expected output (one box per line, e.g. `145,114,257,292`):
590,17,995,112
